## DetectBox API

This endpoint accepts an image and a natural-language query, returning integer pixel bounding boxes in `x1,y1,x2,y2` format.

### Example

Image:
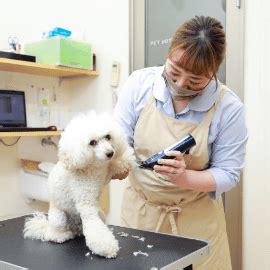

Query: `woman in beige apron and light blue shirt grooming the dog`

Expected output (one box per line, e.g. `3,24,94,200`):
115,16,247,270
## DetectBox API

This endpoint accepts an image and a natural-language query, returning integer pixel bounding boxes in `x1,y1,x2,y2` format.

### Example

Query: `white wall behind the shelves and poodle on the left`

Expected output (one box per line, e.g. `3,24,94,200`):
0,0,129,224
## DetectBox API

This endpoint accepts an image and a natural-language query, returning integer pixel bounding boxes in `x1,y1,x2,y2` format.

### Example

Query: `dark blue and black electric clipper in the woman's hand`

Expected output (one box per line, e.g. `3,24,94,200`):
136,134,196,170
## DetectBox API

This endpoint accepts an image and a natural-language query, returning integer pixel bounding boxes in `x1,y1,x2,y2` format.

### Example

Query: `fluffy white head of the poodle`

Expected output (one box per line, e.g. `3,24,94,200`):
58,111,126,170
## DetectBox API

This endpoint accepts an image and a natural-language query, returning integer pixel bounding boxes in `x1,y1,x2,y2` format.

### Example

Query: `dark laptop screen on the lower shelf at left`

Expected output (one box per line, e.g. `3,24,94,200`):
0,90,27,127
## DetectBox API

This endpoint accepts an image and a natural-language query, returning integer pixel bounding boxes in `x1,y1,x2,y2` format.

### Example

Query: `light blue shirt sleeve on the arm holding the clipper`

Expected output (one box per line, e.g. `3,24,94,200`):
208,102,248,199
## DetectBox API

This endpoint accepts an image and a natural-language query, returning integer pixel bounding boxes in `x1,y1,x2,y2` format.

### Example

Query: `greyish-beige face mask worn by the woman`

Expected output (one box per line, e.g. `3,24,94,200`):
162,69,205,100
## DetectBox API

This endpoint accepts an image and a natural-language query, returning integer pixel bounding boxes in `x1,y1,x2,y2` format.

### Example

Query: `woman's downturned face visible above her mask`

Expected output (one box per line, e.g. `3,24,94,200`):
165,49,212,91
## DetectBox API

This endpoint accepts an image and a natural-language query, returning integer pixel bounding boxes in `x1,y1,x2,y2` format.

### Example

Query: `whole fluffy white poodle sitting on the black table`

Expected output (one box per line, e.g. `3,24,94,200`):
24,112,134,258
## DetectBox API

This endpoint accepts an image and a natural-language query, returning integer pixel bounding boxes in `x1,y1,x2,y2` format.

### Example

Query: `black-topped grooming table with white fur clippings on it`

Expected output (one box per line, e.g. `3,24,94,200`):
0,216,209,270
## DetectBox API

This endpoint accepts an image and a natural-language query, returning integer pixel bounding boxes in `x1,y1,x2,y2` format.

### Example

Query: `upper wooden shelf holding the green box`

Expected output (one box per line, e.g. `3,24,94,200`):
0,58,98,78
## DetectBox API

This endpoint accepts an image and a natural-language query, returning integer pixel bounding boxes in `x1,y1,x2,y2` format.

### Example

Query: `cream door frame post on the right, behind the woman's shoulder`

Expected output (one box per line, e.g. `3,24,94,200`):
224,0,245,270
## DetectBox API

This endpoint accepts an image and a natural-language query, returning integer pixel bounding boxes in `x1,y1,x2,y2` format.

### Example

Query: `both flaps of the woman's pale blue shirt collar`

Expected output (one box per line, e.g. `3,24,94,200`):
153,66,221,112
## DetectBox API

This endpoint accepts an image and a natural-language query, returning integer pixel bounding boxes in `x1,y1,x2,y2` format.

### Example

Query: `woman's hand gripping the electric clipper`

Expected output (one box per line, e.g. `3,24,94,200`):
154,151,186,186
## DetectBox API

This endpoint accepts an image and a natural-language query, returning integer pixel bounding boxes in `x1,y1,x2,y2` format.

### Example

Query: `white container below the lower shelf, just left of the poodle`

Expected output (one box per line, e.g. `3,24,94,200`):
19,169,49,202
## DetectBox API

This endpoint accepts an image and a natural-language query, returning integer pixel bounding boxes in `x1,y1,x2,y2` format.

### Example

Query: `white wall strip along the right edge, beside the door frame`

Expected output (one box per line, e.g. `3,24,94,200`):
243,0,270,270
